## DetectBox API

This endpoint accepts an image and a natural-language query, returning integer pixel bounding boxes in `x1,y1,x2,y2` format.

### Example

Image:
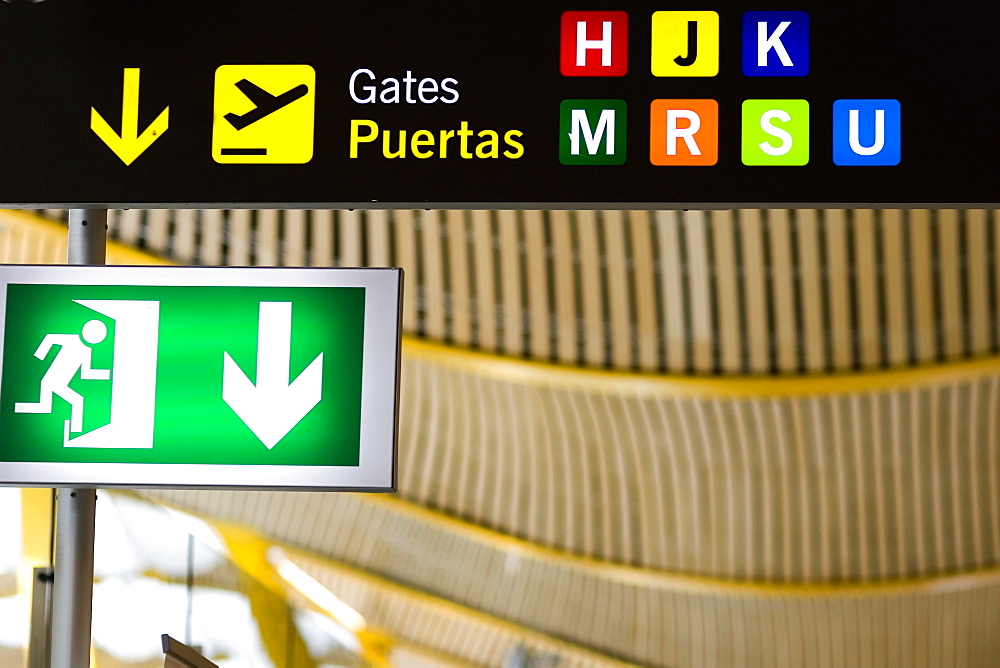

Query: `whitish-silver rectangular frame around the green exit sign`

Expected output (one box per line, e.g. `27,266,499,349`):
0,265,402,492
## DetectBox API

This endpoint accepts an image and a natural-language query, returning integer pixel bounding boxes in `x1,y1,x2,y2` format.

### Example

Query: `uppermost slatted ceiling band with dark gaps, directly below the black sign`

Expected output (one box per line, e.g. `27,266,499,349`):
64,209,1000,374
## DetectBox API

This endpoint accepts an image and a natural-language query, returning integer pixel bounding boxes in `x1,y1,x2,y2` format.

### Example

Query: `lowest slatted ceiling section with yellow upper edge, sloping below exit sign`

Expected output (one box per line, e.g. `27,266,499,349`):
149,491,1000,668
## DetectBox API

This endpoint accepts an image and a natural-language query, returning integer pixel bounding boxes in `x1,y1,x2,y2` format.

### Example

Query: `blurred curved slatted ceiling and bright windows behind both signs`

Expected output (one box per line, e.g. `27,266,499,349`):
0,210,1000,668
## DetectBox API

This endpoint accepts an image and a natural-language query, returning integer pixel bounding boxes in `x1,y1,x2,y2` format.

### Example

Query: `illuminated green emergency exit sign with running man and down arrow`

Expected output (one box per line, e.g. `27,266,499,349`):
0,267,401,490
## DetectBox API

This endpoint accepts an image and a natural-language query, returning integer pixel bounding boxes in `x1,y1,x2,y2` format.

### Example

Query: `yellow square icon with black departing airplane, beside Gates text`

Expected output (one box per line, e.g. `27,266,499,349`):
212,65,316,165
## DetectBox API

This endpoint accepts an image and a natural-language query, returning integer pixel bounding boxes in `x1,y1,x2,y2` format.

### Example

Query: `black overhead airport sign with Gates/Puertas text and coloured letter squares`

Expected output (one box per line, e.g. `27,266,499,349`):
0,0,1000,208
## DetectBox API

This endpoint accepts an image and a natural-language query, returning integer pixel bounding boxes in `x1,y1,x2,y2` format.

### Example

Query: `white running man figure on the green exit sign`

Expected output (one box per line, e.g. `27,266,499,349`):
14,320,111,432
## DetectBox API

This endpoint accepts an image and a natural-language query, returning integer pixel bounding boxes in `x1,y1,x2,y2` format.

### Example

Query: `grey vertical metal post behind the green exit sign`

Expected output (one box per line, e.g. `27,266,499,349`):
52,209,108,668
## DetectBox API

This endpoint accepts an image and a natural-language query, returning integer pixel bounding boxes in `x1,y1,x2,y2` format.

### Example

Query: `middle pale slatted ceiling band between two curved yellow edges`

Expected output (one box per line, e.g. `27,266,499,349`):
135,344,1000,583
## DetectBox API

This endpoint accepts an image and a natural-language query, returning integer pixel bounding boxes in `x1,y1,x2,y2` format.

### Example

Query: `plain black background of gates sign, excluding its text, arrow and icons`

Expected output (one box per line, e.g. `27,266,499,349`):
0,0,1000,208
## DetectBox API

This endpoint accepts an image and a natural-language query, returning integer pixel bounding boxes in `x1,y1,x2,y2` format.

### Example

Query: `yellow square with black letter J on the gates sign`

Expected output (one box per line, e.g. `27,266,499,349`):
652,12,719,77
